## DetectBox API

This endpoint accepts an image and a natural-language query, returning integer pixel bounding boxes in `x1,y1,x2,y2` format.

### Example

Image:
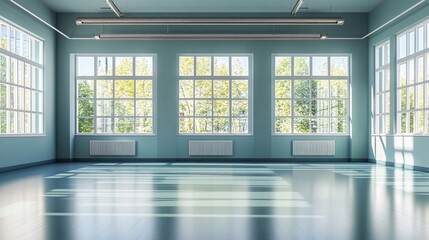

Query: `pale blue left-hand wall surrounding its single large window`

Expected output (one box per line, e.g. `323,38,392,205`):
0,0,56,168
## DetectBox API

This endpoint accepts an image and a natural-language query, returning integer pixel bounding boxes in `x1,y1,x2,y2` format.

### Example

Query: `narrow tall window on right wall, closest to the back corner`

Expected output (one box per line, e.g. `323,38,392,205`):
374,41,390,134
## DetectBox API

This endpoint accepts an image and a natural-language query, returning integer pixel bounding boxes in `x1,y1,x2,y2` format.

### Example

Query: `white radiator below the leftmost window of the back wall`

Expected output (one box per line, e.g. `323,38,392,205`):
89,140,136,156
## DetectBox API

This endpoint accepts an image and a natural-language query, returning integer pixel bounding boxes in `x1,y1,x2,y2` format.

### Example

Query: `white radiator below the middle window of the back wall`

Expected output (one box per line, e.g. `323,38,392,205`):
189,140,233,156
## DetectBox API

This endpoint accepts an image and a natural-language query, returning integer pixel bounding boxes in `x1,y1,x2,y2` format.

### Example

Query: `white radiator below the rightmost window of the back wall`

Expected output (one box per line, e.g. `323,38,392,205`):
292,140,335,156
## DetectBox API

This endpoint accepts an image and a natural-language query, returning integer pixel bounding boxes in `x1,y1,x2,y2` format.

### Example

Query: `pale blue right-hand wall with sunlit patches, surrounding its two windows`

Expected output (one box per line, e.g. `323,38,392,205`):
368,0,429,168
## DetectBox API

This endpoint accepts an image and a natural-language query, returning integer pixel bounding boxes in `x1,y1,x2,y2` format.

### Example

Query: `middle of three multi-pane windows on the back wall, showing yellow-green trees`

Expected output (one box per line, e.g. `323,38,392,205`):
178,55,252,135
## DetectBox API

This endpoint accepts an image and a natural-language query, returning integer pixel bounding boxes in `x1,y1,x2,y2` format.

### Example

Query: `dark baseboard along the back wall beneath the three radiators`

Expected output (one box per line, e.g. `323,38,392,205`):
67,157,368,163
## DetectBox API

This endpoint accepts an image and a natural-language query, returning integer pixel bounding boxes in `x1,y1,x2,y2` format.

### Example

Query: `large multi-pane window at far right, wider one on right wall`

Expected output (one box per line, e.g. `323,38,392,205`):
397,21,429,134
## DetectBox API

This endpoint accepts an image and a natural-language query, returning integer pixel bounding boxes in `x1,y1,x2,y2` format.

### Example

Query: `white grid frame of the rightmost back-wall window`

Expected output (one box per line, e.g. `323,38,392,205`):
271,53,352,136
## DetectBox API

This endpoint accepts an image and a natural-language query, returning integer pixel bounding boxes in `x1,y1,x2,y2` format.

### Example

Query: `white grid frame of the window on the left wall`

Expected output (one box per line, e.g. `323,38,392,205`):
0,17,45,137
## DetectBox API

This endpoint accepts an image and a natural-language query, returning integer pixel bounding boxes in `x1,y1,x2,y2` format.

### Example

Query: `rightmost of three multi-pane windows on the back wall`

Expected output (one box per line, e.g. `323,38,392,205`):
273,55,349,135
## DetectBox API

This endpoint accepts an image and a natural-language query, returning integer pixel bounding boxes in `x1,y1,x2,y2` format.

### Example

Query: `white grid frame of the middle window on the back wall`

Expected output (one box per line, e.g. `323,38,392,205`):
176,53,253,136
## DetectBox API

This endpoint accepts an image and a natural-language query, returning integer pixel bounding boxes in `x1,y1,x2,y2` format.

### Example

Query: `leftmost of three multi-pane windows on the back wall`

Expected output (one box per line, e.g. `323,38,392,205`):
76,55,155,134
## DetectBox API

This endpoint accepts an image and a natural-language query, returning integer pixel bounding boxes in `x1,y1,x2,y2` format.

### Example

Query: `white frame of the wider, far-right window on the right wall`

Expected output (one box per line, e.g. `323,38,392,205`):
396,19,429,135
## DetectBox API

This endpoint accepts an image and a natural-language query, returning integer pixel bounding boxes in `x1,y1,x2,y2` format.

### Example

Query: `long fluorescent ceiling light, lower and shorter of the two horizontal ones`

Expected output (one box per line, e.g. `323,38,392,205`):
94,34,327,40
